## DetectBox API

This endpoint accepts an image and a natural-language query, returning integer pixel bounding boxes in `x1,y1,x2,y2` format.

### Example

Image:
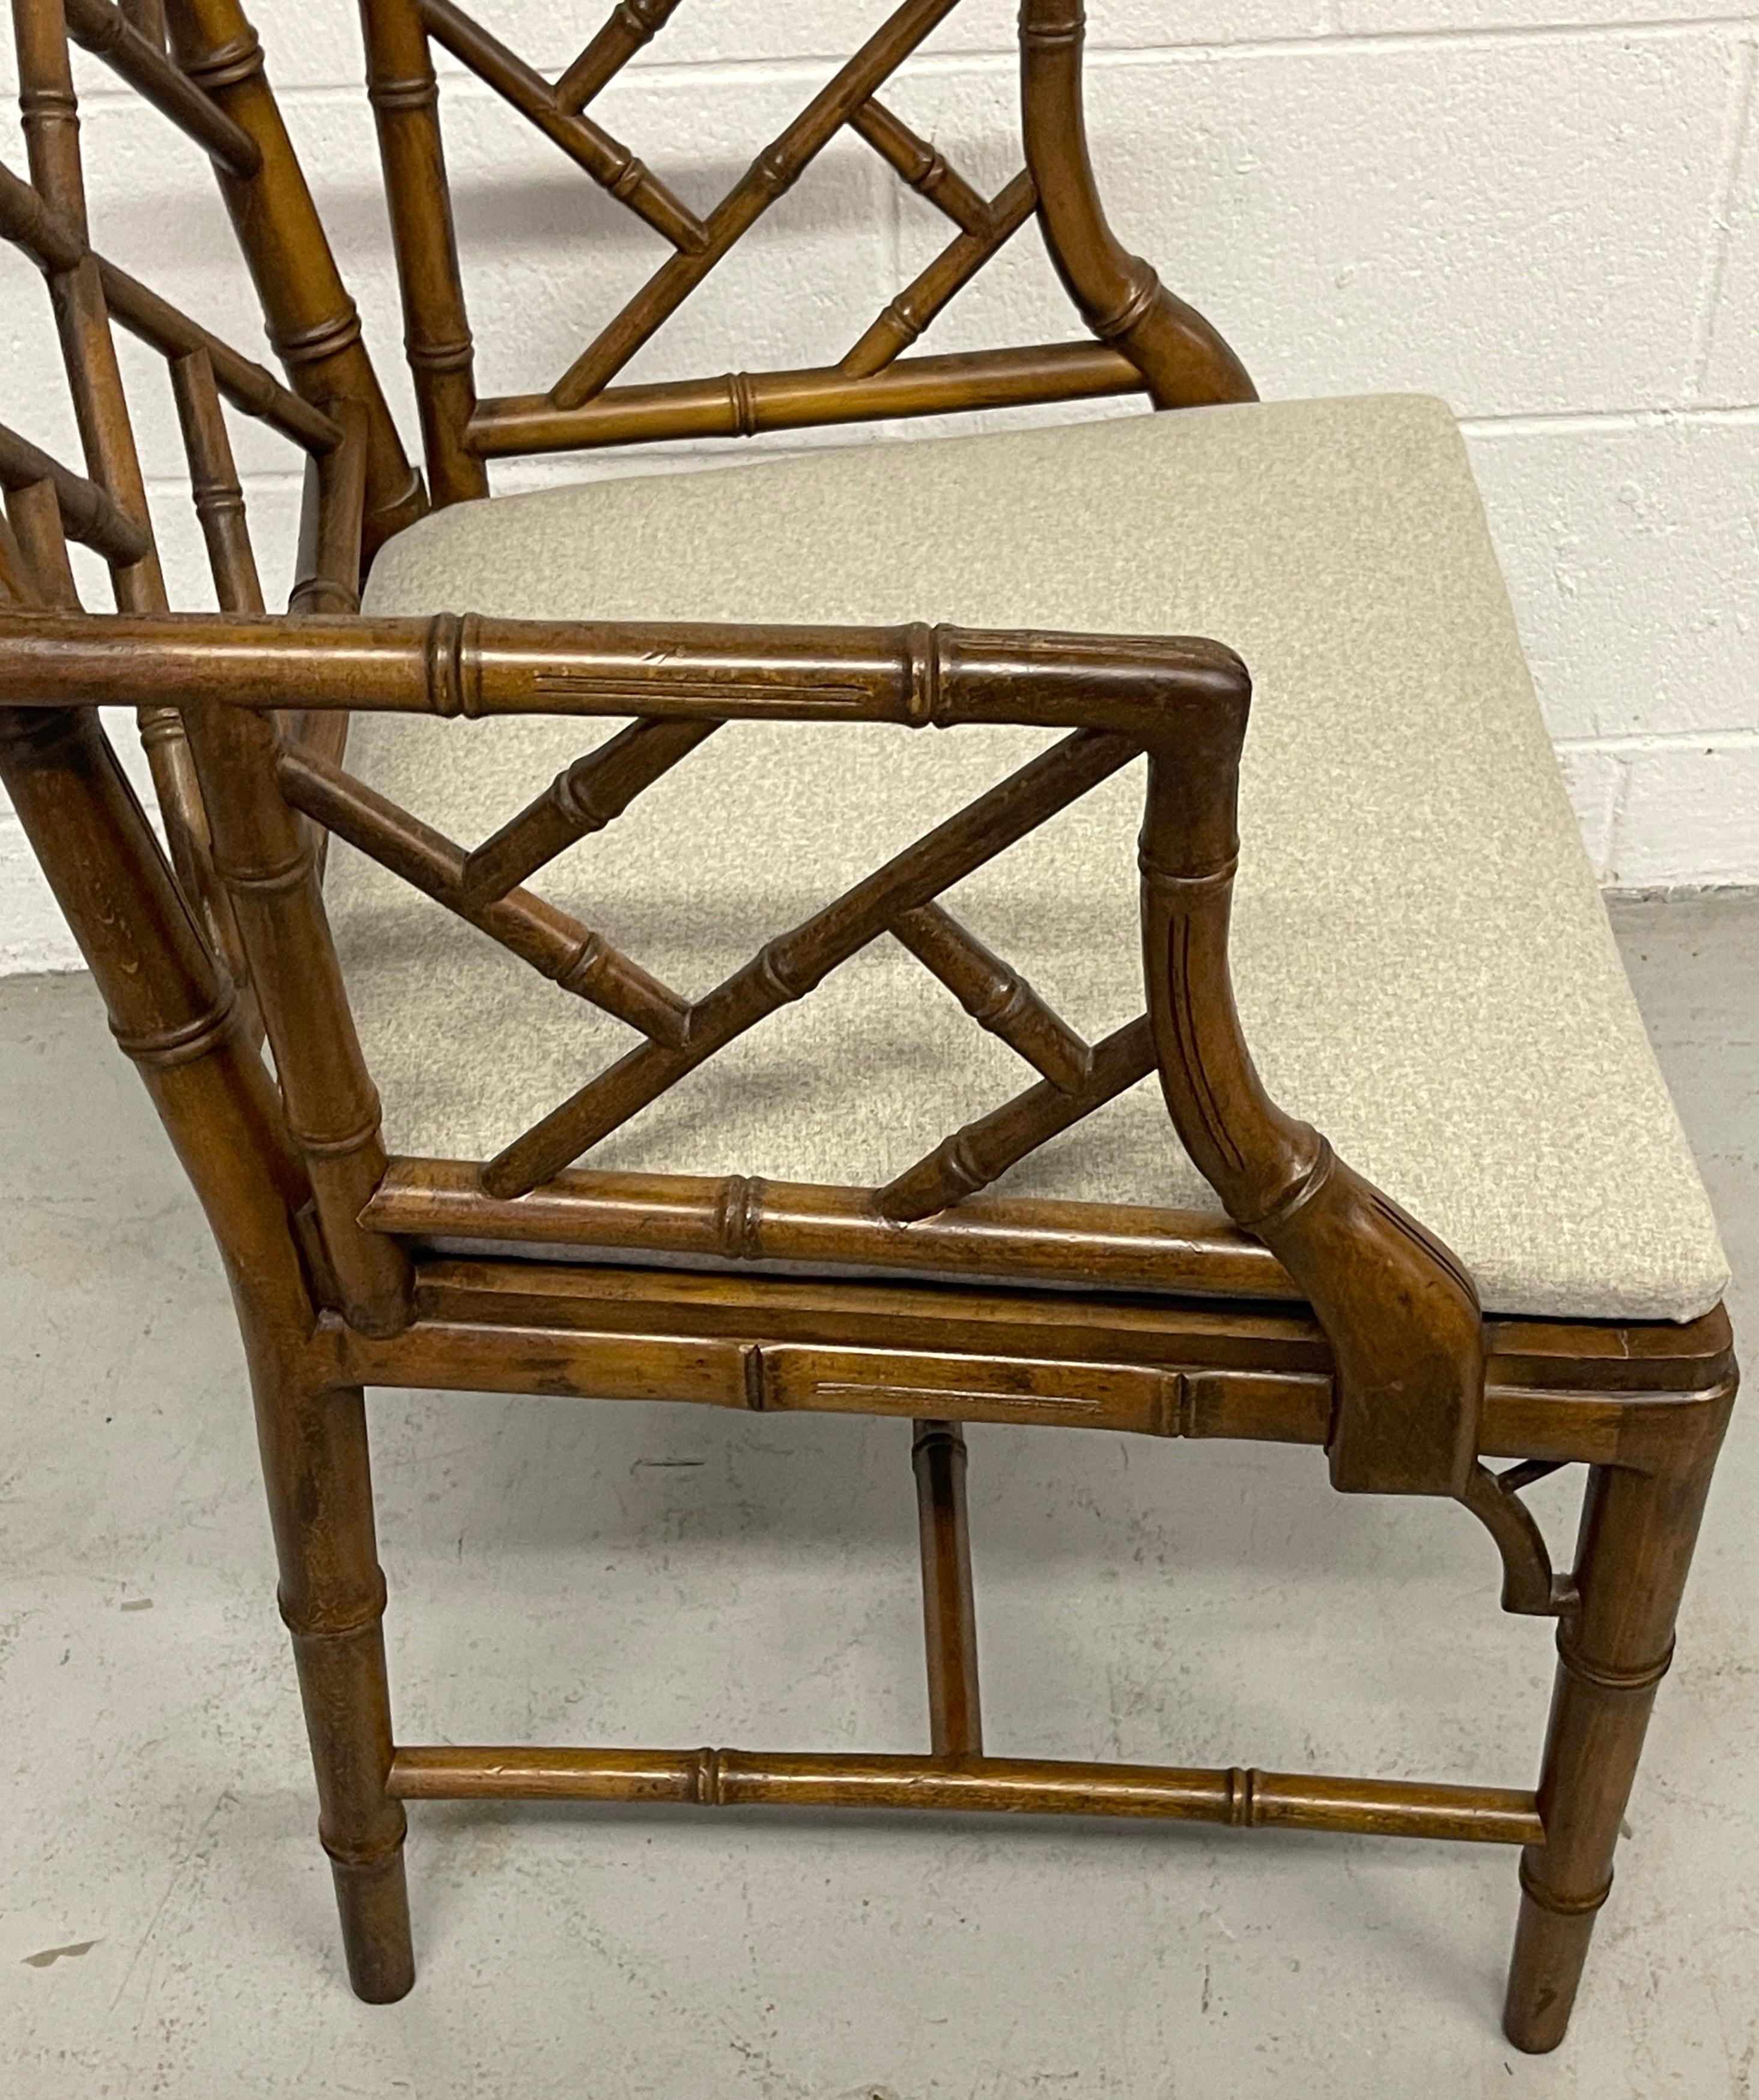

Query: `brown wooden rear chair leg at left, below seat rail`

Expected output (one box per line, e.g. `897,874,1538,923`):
254,1361,416,2006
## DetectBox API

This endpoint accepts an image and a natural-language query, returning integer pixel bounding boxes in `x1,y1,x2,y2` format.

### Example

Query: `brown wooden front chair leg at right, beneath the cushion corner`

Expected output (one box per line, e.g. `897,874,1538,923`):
1503,1395,1732,2054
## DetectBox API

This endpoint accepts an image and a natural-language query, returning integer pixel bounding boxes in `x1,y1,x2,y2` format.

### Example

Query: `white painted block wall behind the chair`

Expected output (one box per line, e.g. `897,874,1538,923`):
0,0,1759,970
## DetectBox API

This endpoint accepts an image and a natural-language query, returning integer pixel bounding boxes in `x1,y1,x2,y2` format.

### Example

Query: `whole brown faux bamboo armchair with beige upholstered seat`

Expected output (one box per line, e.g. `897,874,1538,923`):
0,0,1736,2050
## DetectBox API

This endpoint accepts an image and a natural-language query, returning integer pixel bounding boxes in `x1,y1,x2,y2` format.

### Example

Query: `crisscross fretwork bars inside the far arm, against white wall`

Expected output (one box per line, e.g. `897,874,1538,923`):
420,0,1037,407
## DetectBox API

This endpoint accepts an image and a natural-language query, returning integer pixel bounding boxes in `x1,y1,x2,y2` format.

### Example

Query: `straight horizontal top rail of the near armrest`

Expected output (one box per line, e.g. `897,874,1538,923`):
0,613,1249,741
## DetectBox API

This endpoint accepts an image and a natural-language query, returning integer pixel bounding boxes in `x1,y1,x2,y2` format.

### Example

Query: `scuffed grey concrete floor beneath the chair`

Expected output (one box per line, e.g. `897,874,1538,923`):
0,899,1759,2100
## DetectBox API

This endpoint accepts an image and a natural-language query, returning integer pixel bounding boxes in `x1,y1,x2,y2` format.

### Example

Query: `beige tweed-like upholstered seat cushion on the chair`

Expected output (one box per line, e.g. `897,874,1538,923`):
330,397,1725,1319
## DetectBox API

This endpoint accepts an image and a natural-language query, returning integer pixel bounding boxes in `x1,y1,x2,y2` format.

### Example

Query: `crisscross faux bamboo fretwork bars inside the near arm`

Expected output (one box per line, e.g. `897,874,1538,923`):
281,716,1155,1218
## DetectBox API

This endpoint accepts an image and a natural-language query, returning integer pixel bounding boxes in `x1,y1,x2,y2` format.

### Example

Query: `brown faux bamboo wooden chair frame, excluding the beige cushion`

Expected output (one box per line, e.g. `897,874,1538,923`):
0,0,1736,2050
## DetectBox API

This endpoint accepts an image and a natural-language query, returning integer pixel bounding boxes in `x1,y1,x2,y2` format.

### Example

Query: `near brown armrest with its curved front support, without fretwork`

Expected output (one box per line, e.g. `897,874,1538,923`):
0,611,1484,1495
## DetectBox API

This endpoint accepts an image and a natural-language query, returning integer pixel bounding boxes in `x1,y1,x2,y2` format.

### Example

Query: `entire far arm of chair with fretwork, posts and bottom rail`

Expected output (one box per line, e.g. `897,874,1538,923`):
361,0,1253,504
